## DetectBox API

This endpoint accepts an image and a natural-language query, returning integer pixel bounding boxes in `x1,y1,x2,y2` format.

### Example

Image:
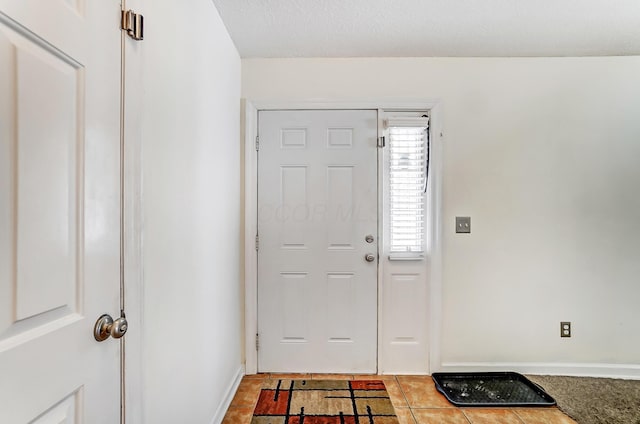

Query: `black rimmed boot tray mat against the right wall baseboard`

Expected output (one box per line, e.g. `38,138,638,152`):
431,372,556,407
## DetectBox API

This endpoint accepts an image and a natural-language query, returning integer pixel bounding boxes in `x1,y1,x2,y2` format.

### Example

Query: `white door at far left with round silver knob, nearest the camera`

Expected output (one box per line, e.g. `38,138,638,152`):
0,0,120,424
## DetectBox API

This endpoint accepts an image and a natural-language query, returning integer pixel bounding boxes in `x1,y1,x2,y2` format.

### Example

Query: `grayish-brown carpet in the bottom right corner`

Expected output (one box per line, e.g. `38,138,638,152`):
527,375,640,424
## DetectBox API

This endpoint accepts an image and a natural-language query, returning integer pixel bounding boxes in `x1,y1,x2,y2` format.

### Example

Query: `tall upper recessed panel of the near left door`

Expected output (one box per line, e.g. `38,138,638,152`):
12,36,84,320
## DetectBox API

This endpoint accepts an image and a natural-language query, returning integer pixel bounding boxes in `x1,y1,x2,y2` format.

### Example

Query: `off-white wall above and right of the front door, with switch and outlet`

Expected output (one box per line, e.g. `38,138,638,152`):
242,57,640,378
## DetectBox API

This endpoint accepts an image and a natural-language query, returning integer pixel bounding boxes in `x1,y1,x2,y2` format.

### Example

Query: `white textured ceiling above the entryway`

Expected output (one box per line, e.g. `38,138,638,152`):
213,0,640,57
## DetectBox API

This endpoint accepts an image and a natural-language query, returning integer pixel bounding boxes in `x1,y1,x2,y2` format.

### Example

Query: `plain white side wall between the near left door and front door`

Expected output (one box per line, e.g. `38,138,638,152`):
142,0,242,424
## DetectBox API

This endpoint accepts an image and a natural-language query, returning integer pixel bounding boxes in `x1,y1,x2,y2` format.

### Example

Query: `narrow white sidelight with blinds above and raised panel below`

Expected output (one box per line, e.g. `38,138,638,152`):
379,110,437,374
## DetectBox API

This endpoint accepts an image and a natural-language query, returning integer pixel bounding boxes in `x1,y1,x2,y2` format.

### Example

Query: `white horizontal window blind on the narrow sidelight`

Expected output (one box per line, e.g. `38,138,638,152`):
387,118,429,253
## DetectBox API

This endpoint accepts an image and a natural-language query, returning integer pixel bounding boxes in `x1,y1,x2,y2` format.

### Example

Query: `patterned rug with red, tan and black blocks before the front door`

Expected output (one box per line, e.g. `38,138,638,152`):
251,380,398,424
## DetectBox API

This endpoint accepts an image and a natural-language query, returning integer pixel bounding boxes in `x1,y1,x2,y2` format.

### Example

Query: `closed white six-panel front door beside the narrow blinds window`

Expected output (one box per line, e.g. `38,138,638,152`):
258,110,378,373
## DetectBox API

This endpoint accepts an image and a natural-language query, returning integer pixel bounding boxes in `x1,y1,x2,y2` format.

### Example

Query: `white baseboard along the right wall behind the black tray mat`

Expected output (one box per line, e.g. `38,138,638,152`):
434,362,640,380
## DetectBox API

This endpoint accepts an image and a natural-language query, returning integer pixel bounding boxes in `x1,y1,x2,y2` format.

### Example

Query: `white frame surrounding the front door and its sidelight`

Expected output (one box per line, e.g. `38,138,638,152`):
240,99,443,374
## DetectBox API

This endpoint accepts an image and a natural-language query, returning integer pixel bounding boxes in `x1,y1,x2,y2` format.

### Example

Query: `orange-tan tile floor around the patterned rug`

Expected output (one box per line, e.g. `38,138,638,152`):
223,374,576,424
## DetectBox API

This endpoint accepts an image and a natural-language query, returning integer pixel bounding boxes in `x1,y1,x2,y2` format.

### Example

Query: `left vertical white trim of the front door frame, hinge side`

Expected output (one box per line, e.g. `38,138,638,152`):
241,99,258,374
